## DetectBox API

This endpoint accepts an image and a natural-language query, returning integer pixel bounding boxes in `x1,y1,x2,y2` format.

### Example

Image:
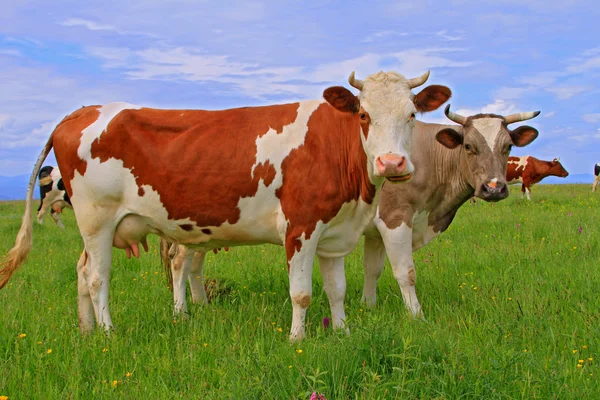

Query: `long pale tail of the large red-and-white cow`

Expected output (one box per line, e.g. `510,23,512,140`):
0,135,53,289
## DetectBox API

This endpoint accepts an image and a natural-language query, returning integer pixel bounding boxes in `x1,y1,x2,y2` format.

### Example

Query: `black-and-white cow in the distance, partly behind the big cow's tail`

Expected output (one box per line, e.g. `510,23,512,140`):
37,165,71,229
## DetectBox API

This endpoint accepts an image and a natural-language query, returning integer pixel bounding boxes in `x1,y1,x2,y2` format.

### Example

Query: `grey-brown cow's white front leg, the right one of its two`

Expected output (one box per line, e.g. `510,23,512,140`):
377,223,423,317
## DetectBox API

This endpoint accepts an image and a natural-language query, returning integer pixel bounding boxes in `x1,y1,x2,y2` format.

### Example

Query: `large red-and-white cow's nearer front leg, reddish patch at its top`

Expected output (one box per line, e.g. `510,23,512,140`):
285,229,320,341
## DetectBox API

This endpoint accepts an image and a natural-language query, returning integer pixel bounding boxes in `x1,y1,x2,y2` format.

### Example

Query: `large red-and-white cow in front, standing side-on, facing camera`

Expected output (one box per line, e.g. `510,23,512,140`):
0,72,450,339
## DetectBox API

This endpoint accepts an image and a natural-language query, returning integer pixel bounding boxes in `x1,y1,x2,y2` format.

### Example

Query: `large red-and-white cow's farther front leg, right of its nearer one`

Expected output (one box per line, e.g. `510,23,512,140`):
319,256,349,332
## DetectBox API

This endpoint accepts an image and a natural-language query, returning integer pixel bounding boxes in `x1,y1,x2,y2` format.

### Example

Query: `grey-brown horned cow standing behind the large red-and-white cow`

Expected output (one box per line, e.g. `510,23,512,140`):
362,105,539,316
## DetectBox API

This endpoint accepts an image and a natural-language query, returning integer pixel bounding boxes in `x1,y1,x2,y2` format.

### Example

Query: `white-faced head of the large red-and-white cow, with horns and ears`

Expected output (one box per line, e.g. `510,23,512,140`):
324,71,451,182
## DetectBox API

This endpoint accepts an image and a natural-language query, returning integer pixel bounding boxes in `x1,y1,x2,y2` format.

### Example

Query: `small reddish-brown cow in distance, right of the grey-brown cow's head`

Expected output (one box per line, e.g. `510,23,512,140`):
506,156,569,200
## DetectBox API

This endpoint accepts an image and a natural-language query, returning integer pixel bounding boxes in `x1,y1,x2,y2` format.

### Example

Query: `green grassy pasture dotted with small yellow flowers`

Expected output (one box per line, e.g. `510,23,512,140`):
0,185,600,400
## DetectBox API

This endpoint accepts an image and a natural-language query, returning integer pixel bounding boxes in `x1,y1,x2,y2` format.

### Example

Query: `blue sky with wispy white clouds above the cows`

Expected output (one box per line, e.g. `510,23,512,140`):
0,0,600,176
